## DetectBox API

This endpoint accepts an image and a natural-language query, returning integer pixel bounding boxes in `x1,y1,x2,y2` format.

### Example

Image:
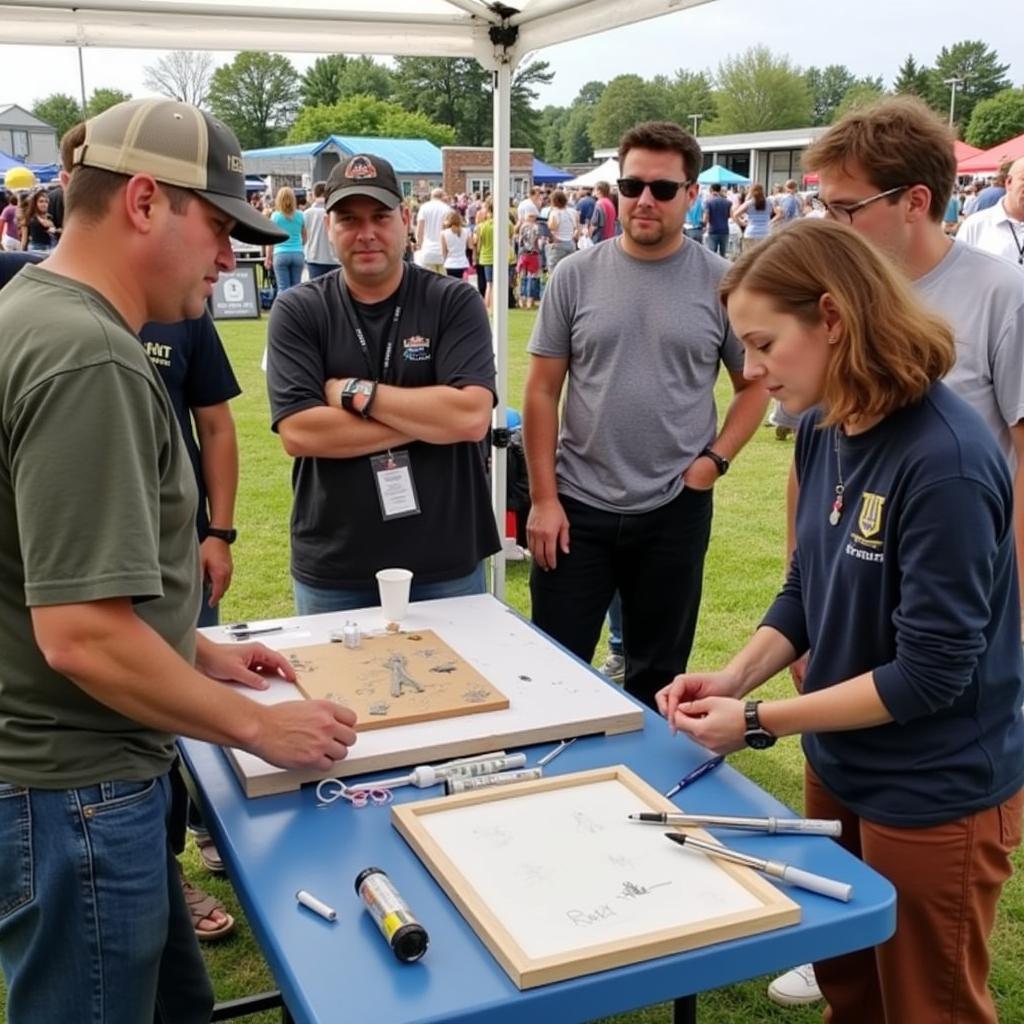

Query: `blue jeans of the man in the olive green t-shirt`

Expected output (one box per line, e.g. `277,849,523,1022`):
0,775,213,1024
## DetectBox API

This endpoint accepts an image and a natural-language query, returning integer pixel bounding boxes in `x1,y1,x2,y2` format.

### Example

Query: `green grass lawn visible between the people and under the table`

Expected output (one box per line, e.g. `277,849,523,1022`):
4,310,1024,1024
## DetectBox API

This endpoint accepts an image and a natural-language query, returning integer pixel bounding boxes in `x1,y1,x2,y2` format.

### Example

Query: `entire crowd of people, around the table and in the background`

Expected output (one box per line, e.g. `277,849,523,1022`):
0,98,1024,1024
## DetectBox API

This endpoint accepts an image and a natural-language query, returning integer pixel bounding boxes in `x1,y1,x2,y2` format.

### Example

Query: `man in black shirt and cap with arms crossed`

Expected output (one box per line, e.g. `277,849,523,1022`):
267,155,500,614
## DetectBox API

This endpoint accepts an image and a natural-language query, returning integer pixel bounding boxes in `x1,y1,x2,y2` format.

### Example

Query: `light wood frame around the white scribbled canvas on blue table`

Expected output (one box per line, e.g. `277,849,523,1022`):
391,765,801,989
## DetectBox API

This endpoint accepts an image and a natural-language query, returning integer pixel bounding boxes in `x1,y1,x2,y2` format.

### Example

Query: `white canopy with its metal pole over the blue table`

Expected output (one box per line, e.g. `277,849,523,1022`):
0,0,710,596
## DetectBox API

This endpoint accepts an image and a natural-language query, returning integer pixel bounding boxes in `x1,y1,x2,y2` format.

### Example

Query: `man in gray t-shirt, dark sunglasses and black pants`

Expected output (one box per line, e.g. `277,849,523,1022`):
523,122,767,708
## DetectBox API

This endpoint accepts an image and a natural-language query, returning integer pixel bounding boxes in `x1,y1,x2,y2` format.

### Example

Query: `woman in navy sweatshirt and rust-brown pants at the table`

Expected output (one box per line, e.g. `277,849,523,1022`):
658,220,1024,1024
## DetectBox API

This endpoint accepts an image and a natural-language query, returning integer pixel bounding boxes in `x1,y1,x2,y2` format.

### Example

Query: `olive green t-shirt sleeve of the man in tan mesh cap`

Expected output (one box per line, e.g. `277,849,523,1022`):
9,362,169,606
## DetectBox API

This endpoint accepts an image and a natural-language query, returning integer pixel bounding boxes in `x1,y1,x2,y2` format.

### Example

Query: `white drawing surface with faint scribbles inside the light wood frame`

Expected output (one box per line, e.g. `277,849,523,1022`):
419,779,763,959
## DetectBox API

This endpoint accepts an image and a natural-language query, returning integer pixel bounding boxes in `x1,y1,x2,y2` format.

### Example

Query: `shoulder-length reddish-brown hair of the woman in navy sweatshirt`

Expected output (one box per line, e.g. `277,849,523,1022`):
719,219,955,427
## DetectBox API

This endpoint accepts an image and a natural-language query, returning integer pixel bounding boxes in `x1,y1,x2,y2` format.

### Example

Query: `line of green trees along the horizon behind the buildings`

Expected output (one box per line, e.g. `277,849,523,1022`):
33,40,1024,164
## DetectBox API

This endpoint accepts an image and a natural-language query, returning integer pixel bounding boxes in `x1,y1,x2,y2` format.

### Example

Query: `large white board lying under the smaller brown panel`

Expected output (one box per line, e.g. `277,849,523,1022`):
204,595,643,796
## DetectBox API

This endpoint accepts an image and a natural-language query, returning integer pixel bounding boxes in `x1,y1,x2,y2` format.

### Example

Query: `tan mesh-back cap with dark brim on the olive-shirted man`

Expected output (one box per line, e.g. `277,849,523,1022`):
72,99,288,246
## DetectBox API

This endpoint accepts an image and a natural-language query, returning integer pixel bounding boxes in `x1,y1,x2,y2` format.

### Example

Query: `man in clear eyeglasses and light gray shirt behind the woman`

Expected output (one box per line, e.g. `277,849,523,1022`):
768,96,1024,1020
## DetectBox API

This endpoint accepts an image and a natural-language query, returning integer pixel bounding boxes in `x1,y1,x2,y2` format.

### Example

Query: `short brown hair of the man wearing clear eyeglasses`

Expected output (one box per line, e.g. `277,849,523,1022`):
804,96,956,221
